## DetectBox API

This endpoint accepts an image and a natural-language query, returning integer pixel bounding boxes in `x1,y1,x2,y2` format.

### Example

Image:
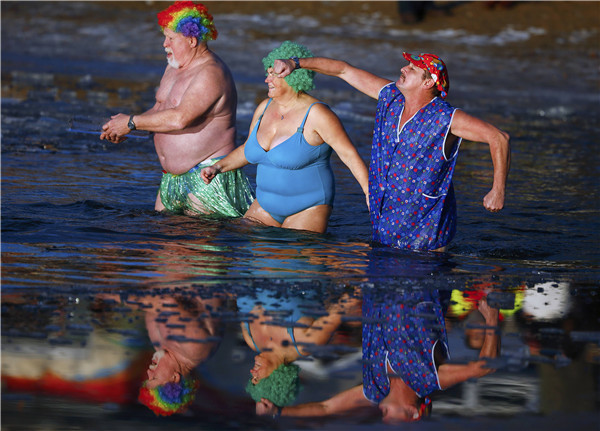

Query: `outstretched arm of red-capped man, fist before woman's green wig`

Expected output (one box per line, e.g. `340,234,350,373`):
273,57,391,99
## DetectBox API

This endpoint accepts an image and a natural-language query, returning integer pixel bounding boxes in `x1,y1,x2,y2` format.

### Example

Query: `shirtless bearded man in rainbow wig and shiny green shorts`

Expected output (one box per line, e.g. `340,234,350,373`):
100,1,254,217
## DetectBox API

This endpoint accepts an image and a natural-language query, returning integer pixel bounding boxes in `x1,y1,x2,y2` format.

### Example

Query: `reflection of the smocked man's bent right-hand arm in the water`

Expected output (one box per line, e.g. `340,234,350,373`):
438,298,500,389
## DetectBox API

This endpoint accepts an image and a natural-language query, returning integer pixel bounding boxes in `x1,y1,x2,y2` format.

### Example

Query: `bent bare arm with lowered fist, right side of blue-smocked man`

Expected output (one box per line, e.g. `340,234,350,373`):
450,110,510,212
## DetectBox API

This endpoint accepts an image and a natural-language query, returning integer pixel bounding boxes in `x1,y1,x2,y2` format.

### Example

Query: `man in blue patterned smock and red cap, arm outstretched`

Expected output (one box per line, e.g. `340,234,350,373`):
273,52,510,251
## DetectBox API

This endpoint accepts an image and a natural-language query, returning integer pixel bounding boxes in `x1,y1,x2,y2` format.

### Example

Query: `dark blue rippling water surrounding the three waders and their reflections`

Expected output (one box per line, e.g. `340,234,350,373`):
1,2,600,430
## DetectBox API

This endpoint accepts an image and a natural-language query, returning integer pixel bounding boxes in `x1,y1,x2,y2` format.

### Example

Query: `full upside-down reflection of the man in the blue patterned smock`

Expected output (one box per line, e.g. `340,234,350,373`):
257,286,500,423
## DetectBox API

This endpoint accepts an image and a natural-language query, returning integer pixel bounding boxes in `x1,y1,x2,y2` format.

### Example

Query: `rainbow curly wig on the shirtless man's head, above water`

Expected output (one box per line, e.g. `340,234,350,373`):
157,1,218,42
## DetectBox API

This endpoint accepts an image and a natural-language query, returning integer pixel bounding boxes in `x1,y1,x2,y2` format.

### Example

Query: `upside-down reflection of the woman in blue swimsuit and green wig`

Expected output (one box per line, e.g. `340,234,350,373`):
237,285,358,407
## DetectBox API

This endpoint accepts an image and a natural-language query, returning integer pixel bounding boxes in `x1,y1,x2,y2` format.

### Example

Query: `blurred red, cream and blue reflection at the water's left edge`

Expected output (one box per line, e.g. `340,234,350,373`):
2,292,149,405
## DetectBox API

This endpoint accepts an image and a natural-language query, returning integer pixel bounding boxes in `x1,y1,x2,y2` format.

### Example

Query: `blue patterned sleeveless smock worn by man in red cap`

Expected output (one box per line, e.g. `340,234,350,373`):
369,83,460,250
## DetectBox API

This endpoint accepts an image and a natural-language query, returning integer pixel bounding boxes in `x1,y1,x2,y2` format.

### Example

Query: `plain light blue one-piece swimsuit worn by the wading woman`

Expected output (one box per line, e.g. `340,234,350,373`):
244,99,335,223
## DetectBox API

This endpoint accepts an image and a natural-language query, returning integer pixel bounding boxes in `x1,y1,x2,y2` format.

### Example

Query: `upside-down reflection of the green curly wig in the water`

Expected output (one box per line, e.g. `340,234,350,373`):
246,364,300,407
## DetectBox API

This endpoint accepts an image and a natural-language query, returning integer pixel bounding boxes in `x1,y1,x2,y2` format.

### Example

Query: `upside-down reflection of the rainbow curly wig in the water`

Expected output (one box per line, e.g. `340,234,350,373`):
138,377,200,416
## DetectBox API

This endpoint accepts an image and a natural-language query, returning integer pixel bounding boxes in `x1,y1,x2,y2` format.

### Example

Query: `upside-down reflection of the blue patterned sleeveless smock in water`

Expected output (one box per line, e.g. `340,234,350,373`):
362,290,448,404
